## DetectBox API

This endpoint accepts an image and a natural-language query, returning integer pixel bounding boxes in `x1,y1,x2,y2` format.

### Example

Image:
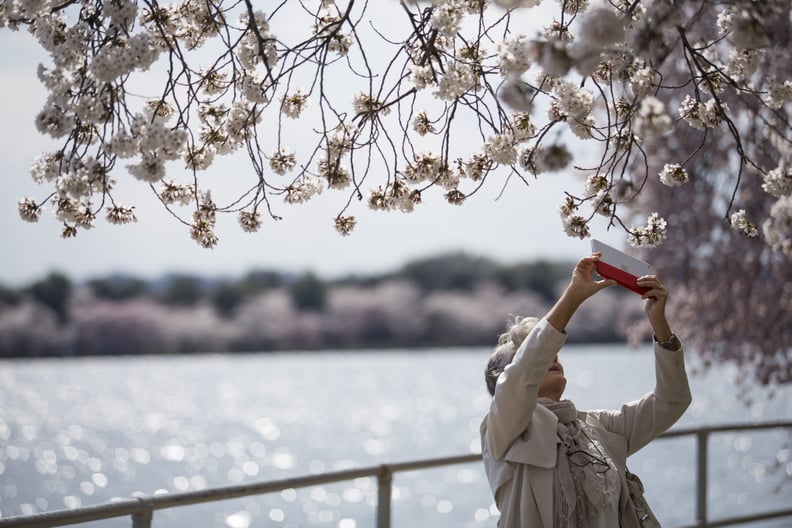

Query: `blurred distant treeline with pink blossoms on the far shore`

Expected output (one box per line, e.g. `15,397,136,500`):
0,253,642,357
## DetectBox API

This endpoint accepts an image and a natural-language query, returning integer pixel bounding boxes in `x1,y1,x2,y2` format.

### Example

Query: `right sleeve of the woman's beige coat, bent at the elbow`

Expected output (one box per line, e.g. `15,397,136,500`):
590,343,692,456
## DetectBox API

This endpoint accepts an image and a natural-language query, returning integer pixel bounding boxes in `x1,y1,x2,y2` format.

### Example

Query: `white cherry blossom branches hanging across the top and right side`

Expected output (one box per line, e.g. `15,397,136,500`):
0,0,792,378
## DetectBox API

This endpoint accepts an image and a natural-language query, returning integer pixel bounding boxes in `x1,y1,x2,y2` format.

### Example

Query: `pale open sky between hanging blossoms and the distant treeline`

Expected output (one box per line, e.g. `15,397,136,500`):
0,7,626,285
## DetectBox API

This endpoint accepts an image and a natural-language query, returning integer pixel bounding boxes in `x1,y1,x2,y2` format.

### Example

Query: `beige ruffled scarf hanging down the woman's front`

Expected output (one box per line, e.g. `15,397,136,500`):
539,398,619,528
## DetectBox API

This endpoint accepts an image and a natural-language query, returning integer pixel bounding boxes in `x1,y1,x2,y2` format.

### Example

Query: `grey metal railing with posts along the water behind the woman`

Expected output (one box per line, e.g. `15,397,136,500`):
0,422,792,528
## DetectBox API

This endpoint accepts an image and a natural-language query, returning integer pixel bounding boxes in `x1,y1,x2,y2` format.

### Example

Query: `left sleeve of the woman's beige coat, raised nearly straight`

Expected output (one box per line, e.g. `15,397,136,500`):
485,319,566,459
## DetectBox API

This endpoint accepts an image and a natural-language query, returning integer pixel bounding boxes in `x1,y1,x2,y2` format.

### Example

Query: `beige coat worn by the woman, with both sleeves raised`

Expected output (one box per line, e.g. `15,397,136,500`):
481,319,691,528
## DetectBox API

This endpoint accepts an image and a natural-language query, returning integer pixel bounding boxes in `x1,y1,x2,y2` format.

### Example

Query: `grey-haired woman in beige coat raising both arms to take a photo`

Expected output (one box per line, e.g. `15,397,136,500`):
481,253,691,528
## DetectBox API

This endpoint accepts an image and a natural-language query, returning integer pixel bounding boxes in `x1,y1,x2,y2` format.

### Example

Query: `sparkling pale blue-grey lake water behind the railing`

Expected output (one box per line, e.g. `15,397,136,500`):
0,345,792,528
